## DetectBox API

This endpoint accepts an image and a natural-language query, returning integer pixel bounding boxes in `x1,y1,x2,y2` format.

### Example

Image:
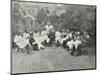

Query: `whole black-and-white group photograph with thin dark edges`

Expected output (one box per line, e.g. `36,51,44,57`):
11,0,96,74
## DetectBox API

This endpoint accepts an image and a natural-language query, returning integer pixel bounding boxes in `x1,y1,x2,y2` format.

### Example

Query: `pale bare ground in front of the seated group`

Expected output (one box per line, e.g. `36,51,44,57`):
12,47,95,73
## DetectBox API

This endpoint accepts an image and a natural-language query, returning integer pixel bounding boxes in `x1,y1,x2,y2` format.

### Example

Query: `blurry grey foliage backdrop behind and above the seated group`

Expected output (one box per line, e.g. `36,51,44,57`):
12,1,96,43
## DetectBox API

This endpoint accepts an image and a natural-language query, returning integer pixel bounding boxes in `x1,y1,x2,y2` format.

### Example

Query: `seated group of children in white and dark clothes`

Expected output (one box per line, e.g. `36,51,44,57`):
14,23,90,55
